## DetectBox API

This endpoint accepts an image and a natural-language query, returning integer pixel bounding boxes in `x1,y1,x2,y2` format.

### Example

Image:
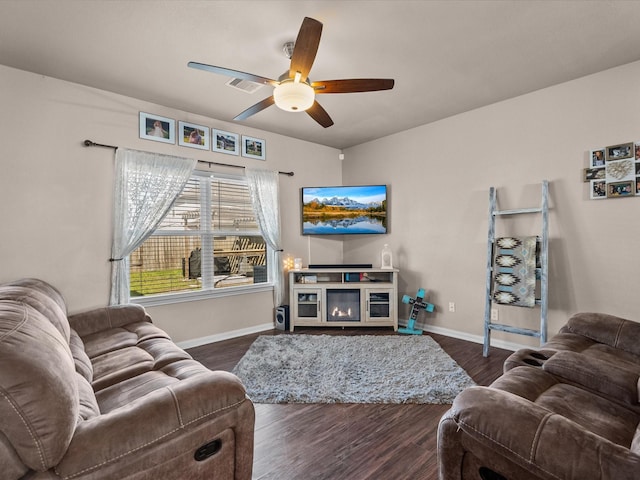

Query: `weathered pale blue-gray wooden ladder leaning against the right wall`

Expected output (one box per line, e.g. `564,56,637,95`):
482,180,549,357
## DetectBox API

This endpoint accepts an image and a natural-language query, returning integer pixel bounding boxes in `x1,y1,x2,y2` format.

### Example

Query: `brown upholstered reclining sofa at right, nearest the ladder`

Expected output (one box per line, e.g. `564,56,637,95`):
438,313,640,480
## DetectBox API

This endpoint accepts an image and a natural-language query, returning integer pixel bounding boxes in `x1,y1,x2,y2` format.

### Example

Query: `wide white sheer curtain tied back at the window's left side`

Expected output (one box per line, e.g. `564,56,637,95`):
109,148,197,305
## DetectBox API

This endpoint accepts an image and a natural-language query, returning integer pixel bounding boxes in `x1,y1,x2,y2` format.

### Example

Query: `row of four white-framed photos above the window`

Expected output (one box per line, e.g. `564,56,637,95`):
139,112,267,160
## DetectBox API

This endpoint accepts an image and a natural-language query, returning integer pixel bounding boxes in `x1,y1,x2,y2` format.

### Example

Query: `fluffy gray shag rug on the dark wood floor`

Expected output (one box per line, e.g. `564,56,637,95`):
233,335,475,404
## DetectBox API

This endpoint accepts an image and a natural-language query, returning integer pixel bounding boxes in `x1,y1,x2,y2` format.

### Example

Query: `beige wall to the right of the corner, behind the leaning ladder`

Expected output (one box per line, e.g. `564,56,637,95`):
343,63,640,345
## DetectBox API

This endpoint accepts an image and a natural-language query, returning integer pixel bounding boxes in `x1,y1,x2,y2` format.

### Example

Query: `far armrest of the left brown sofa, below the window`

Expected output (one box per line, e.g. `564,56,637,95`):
68,304,152,337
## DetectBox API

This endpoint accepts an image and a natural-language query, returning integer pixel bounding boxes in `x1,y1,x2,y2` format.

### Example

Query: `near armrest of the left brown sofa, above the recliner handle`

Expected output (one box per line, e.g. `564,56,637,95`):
56,371,254,478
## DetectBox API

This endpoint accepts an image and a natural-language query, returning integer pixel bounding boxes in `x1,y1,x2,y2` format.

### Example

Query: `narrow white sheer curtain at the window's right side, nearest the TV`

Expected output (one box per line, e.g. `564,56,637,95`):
245,167,284,307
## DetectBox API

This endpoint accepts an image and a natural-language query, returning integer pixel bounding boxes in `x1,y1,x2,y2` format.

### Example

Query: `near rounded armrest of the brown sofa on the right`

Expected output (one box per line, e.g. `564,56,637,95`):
438,386,640,480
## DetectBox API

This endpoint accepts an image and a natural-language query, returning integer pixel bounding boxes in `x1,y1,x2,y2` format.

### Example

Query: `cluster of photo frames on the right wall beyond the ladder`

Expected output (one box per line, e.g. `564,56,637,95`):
583,141,640,200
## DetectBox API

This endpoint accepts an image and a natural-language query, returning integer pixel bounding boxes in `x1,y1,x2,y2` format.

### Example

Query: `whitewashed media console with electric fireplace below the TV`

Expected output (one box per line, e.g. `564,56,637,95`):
289,267,398,332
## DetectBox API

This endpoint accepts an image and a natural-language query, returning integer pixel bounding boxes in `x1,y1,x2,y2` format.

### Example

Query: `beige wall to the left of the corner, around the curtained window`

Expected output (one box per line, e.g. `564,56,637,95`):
0,66,342,342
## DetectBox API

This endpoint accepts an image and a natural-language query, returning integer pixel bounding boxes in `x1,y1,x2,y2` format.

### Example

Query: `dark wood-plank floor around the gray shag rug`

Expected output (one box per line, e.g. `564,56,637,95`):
188,328,512,480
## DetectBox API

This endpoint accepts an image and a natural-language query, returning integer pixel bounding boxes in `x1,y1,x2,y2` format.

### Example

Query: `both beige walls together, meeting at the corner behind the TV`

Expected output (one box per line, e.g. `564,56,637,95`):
5,58,640,344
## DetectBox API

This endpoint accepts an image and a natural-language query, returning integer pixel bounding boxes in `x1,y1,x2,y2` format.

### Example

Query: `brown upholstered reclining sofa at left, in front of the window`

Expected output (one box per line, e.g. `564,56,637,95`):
0,279,254,480
